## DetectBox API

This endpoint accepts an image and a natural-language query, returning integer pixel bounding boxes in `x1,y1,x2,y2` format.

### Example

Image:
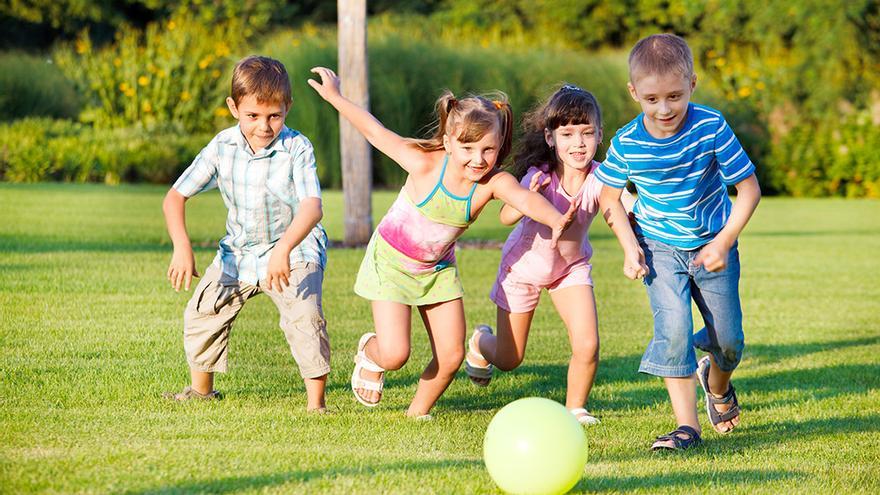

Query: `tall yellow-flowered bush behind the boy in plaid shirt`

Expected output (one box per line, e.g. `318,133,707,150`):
55,10,246,132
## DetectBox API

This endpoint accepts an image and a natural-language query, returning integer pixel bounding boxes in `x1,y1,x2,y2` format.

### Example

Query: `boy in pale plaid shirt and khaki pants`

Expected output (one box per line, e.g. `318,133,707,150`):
162,56,330,412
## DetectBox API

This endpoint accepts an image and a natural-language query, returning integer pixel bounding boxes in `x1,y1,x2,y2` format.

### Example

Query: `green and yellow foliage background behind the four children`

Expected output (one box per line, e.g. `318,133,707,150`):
0,0,880,197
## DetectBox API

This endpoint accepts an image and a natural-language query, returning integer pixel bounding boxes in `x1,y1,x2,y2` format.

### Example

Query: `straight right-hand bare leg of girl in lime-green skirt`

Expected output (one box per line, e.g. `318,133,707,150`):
406,299,465,416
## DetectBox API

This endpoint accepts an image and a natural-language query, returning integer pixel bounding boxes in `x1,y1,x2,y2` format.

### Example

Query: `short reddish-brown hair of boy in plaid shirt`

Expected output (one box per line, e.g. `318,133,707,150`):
232,55,292,108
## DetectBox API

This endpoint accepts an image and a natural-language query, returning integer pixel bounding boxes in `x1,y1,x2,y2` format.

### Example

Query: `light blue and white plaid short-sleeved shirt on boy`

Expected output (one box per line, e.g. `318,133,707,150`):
173,126,327,285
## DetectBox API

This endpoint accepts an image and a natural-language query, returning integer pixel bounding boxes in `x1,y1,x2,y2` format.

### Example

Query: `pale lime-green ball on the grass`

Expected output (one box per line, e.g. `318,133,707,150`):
483,397,587,494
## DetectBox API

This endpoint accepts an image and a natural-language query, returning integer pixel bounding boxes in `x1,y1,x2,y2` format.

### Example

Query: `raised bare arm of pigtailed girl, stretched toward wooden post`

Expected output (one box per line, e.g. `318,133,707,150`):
308,67,423,172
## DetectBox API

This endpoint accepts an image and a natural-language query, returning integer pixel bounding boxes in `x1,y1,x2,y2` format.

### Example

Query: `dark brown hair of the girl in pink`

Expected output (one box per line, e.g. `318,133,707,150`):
510,84,602,179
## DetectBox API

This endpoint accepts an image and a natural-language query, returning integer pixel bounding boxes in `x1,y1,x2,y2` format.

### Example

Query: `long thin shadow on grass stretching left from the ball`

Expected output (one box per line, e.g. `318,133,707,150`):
124,460,483,495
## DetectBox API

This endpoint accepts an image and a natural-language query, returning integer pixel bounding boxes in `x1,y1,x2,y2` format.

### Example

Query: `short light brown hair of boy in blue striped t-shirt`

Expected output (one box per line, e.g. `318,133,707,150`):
629,34,694,82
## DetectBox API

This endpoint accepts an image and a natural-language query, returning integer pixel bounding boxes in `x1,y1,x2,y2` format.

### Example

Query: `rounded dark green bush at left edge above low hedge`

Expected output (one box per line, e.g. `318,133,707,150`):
0,53,80,121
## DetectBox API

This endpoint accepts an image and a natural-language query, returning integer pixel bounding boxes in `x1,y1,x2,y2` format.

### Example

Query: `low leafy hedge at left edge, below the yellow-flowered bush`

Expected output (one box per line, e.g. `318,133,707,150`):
0,119,212,184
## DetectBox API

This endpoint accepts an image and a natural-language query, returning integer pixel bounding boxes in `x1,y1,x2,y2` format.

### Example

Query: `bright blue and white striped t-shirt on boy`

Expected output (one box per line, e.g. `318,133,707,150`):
596,103,755,249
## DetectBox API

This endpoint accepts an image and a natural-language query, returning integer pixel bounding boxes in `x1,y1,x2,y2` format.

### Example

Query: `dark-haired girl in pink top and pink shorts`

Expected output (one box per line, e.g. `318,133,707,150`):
465,85,631,425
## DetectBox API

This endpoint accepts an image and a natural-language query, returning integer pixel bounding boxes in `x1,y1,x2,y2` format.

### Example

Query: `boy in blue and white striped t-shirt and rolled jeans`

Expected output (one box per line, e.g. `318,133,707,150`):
596,34,761,450
